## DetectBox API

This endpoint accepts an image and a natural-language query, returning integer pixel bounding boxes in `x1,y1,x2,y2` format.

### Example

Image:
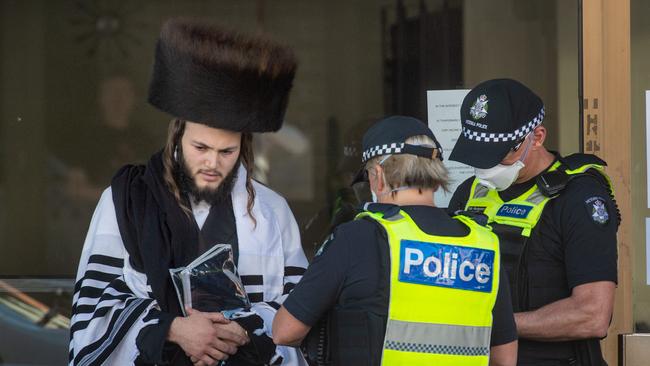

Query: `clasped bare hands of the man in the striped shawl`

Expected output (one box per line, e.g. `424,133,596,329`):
167,309,247,365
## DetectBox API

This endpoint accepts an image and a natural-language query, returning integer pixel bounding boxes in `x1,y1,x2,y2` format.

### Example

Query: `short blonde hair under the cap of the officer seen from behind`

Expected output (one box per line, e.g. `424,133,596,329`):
366,135,449,195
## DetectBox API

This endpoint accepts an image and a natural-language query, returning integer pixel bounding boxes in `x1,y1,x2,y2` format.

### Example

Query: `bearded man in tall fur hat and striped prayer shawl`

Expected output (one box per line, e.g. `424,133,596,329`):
70,19,307,365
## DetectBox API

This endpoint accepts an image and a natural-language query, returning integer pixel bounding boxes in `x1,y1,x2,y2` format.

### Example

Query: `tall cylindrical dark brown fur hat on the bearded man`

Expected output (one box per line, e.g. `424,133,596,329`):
149,18,297,132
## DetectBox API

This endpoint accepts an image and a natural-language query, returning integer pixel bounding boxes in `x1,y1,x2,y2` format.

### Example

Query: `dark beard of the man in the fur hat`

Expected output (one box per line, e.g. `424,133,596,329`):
174,146,240,205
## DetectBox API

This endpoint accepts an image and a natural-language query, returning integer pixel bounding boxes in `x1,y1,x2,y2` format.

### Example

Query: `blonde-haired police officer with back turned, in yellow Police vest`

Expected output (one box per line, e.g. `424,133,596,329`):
273,116,517,365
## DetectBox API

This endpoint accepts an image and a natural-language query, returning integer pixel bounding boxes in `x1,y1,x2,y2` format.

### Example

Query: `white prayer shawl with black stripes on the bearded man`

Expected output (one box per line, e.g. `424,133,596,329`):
69,158,307,365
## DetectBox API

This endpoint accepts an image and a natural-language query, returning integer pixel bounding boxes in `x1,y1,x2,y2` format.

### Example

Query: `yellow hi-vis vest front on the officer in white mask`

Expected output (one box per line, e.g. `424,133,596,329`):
465,161,613,237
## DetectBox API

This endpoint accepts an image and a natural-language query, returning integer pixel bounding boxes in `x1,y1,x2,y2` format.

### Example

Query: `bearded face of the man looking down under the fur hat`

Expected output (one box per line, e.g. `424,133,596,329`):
181,122,241,193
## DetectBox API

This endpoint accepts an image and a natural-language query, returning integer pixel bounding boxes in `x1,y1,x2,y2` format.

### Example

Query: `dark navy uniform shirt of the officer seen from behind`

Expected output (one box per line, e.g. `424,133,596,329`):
284,206,517,349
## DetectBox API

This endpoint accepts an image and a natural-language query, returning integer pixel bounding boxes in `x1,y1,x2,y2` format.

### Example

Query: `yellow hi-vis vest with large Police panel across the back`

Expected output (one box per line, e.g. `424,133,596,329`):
357,211,500,366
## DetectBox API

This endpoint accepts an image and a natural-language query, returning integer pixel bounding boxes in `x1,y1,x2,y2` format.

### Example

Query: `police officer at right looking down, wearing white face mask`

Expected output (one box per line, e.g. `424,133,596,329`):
449,79,620,365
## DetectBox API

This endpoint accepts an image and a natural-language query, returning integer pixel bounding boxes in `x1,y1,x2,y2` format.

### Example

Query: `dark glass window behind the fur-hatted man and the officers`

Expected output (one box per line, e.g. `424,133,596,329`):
0,0,578,364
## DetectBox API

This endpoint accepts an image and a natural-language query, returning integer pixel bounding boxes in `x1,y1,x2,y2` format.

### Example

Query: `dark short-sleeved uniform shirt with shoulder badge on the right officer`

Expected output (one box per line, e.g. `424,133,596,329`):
448,157,618,364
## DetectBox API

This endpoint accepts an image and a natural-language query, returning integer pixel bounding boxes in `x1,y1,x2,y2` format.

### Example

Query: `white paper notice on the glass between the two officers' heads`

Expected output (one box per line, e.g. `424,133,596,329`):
427,89,474,207
